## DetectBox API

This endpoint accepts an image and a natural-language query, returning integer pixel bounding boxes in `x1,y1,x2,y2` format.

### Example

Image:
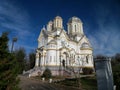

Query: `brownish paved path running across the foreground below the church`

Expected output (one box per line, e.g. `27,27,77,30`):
19,76,78,90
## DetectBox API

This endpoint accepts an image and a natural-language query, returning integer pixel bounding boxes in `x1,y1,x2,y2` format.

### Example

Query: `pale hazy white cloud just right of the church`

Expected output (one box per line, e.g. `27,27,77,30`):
89,28,120,55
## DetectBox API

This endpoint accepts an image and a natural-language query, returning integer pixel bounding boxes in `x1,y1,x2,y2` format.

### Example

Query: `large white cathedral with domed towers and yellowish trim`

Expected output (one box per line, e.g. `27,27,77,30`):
35,16,93,75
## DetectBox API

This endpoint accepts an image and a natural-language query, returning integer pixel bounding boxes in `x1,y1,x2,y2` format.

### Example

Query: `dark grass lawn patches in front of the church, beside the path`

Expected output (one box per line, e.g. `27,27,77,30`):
32,76,97,90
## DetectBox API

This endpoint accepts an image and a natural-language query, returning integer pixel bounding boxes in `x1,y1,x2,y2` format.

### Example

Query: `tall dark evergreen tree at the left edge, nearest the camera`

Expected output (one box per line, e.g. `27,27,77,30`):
0,32,18,90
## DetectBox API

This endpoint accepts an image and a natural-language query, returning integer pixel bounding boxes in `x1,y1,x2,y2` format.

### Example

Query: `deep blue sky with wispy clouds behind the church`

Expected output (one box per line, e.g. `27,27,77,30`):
0,0,120,55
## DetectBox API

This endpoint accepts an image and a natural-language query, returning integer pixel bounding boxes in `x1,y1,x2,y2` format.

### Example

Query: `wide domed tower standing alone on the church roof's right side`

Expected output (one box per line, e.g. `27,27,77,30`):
67,16,83,35
